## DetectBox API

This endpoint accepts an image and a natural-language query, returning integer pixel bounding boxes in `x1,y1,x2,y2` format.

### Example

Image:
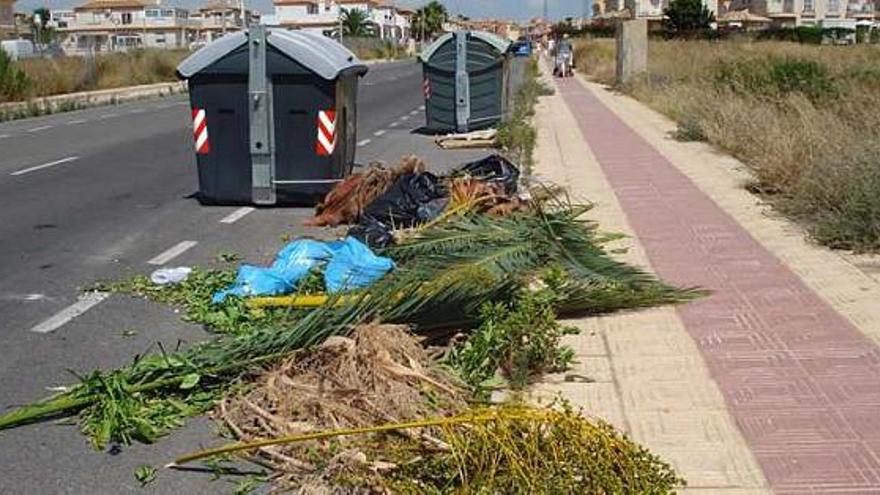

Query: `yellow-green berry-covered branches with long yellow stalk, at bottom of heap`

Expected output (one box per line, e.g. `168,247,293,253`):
172,404,685,495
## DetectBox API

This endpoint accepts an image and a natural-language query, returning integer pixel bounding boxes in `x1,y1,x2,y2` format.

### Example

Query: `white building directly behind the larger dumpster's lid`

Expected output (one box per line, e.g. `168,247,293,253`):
266,0,412,41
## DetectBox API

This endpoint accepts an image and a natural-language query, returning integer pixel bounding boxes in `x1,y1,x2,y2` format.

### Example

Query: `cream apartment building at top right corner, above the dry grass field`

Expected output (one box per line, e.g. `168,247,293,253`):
727,0,875,27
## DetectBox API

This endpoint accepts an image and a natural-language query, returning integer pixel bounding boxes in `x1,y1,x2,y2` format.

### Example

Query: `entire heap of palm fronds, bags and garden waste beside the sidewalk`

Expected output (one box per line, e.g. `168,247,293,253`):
0,156,699,493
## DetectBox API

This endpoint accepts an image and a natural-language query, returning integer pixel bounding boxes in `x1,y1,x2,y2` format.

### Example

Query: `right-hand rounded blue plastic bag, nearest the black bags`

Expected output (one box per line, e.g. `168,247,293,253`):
324,237,394,294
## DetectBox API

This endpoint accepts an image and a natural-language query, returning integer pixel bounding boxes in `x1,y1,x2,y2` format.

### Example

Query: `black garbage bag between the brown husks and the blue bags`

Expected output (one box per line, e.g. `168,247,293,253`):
348,172,448,248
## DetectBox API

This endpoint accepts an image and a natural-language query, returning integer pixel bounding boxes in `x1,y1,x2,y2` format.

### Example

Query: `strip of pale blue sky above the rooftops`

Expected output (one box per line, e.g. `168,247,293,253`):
15,0,591,21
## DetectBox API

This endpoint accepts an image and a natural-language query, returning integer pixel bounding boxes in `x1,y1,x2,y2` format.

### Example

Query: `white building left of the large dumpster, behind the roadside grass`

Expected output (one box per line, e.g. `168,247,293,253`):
58,0,199,54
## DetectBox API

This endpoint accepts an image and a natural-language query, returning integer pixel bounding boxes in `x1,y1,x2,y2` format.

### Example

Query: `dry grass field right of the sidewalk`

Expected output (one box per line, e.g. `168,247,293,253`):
578,40,880,251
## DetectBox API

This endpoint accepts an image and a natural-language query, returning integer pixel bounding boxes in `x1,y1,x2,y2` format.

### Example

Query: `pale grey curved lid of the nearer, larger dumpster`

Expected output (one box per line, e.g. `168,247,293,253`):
177,29,367,80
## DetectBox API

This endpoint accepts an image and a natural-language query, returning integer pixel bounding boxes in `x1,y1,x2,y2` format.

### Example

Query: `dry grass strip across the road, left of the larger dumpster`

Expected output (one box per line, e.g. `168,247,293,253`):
0,50,189,101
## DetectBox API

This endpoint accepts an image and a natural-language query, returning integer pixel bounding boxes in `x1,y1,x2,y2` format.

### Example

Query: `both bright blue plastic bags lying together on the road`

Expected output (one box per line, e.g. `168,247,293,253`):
213,237,394,304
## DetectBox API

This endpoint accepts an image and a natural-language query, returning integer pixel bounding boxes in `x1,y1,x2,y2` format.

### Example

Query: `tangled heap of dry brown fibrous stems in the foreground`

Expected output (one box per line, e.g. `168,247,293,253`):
214,323,467,488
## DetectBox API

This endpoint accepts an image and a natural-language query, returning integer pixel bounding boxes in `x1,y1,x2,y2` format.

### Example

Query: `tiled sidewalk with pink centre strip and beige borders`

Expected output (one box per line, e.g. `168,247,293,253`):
539,68,880,493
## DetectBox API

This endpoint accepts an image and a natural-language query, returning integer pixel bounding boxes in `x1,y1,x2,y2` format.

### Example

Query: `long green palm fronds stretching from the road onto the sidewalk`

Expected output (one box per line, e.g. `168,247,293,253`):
0,191,697,445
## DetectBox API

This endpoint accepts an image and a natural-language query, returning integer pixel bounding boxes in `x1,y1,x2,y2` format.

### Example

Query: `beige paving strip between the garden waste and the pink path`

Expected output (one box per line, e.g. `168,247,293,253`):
531,64,768,495
